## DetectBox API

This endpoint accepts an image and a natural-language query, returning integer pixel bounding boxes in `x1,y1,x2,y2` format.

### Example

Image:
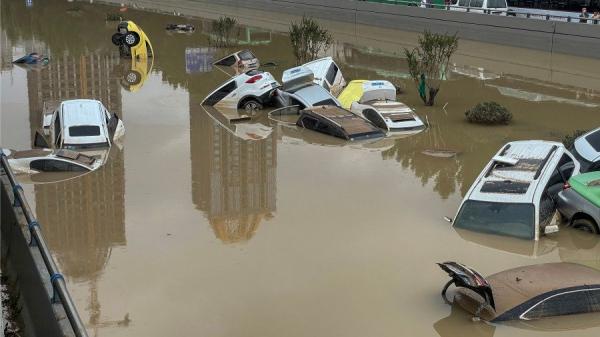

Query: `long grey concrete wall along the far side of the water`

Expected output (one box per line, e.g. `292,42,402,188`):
111,0,600,59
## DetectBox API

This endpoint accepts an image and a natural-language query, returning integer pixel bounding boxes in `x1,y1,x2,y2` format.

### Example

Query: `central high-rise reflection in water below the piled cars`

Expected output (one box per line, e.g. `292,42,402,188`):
190,98,277,243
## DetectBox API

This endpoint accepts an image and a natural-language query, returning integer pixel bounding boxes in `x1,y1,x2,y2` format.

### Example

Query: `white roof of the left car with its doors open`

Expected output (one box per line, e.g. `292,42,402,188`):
61,99,104,127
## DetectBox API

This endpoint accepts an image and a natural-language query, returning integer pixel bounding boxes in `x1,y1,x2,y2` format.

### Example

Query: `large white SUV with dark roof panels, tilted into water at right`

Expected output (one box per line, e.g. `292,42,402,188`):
448,140,579,240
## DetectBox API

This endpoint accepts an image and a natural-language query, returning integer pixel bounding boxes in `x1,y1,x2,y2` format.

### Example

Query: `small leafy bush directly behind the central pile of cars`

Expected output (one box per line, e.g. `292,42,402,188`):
290,16,333,64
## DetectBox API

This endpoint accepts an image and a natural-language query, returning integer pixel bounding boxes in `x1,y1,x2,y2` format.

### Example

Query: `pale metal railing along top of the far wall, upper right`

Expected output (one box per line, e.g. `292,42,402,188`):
359,0,600,25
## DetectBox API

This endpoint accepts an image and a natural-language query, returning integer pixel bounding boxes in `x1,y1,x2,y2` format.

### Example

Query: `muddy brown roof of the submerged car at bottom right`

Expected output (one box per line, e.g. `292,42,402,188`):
486,262,600,314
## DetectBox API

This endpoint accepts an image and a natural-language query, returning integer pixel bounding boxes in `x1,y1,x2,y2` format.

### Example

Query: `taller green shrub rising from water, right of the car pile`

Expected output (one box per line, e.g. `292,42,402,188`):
404,31,458,106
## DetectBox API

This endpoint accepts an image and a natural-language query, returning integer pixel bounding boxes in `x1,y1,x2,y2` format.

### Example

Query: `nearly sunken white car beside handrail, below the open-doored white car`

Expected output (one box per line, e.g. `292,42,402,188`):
2,149,102,174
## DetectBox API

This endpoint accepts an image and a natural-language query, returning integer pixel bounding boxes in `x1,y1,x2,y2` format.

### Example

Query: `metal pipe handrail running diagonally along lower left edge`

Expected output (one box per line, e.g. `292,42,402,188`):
0,153,88,337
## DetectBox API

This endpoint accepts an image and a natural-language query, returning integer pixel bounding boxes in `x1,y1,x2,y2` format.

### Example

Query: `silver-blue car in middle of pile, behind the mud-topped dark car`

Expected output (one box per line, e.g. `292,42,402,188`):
277,66,341,110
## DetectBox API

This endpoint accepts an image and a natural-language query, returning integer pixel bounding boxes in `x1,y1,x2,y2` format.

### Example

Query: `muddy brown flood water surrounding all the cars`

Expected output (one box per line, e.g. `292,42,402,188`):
0,0,600,337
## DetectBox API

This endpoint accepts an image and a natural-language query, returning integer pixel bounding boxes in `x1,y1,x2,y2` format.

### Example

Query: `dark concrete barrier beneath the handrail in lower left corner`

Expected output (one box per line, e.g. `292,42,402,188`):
0,169,75,337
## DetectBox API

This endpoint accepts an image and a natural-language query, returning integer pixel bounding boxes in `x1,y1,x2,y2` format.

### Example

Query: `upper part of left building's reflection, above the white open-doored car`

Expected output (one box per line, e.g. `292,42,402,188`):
27,54,121,140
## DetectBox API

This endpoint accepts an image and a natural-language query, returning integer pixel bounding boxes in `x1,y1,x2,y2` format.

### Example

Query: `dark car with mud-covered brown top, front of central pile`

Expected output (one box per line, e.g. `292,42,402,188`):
296,105,384,140
